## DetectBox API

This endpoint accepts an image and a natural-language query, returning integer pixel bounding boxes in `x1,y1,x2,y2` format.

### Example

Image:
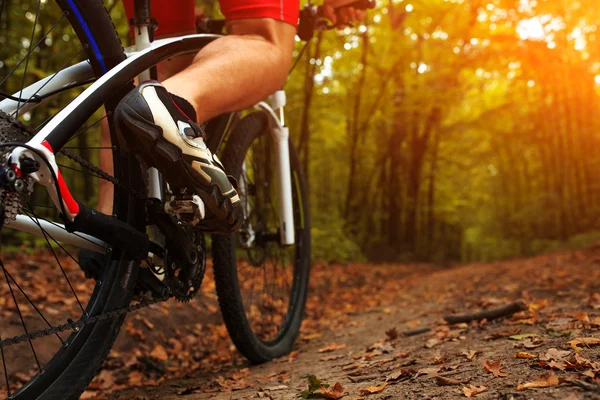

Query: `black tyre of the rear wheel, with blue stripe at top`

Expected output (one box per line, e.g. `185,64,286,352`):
2,0,143,400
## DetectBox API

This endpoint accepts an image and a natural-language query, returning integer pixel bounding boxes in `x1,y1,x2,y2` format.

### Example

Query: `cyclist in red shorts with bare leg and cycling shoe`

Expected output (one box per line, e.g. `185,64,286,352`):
116,0,364,232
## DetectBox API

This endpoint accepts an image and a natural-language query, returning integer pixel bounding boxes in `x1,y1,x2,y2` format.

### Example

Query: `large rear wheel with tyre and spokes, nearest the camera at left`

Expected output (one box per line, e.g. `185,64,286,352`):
0,0,143,400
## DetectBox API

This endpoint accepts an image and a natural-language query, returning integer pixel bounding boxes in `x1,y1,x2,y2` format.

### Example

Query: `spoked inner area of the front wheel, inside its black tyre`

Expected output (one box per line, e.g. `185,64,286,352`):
237,131,307,346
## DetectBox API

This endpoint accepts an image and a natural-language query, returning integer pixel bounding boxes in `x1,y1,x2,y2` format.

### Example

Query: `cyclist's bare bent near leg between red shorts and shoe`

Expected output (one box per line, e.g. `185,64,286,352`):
164,18,296,122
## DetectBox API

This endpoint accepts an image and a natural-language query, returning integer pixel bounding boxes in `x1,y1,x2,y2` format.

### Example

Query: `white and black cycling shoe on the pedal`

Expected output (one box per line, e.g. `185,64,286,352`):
115,81,241,232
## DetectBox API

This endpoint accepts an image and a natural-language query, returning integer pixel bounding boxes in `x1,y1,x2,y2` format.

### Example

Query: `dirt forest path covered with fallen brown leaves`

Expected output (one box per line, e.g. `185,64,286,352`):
88,245,600,400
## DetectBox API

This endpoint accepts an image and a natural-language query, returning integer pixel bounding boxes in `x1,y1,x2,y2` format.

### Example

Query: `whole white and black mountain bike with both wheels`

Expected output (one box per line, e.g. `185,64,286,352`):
0,0,372,400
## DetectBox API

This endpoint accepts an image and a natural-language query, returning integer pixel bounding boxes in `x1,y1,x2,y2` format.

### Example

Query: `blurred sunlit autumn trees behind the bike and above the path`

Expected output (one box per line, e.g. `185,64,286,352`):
0,0,600,262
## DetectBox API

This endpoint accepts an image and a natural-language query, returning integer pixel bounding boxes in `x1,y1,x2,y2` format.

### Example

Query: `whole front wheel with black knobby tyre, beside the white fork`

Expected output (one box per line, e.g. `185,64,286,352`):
213,112,310,363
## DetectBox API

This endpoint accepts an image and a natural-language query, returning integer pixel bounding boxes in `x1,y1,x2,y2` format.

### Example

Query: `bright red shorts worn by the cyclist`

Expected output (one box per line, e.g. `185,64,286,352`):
124,0,300,36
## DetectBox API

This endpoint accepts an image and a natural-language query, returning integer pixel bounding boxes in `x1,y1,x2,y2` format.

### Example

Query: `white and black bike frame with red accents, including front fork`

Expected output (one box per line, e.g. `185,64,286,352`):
0,34,295,251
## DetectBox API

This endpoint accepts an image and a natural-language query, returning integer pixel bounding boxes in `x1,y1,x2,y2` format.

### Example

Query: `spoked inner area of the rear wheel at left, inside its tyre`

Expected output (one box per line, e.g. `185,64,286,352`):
0,0,132,399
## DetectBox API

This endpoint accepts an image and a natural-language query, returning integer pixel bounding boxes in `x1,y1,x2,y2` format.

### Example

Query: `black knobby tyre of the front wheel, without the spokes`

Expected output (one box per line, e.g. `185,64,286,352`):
212,112,310,363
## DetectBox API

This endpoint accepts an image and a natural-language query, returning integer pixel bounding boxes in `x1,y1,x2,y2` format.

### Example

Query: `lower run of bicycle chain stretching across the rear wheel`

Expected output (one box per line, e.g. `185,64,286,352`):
0,295,173,349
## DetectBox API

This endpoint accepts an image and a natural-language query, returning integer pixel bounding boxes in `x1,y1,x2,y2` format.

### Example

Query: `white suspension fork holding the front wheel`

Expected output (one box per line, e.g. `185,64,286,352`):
256,90,295,246
